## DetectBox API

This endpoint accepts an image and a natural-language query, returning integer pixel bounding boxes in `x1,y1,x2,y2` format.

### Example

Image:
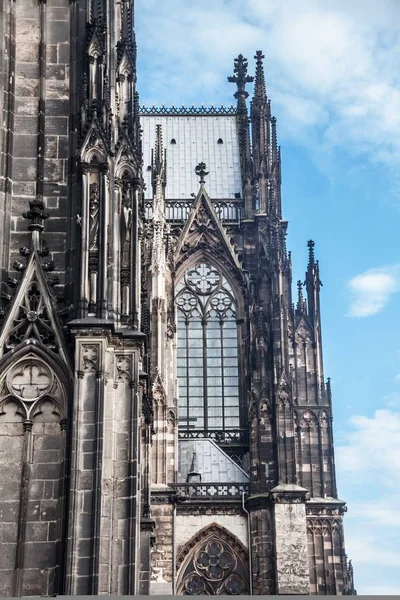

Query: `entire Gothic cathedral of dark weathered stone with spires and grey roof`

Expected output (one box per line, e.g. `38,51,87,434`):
0,0,356,597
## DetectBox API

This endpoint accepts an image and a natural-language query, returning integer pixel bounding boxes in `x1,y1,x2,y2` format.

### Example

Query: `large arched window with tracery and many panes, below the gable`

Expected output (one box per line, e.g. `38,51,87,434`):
176,261,240,431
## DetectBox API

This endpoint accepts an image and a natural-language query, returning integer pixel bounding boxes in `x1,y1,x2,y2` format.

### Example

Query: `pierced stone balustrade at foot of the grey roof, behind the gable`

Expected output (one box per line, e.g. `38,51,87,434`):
144,199,242,224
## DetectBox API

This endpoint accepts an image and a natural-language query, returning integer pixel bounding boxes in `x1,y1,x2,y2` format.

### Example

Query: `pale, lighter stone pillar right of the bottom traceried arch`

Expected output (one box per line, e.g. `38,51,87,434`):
270,484,310,595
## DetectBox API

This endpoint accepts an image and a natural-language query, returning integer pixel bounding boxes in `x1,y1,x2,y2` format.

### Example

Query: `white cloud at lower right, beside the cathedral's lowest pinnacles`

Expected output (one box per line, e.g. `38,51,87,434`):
336,406,400,595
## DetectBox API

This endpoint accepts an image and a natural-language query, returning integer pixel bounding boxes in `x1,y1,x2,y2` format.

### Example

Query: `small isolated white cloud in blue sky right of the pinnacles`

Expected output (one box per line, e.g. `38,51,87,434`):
347,266,400,317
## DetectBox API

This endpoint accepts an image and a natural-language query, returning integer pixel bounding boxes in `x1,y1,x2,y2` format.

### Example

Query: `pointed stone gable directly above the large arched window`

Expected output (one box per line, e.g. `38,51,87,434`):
175,185,241,269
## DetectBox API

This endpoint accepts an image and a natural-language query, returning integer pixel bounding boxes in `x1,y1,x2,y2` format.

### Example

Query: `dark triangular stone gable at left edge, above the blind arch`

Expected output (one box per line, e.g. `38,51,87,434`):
0,252,69,366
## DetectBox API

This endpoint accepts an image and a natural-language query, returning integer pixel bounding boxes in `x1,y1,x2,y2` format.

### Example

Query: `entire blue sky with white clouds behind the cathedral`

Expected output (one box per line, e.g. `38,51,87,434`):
136,0,400,594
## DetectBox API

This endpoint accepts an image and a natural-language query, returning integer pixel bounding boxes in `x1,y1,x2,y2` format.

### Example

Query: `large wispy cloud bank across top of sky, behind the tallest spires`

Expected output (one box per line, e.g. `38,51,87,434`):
137,0,400,165
